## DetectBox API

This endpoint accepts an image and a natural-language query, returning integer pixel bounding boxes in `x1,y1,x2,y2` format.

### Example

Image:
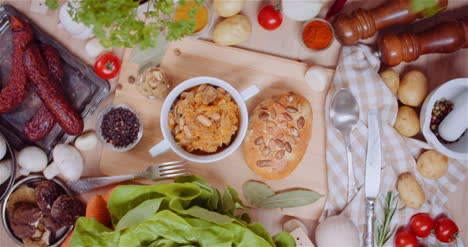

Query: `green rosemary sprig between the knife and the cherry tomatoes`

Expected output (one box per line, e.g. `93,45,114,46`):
377,191,398,247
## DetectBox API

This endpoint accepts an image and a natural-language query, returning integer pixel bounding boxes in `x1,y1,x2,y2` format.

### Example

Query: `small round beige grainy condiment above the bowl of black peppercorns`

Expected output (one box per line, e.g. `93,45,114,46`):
135,67,171,99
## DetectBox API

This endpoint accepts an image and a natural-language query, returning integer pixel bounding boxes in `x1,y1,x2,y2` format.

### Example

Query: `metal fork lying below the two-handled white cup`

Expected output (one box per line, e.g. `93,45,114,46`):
67,161,192,194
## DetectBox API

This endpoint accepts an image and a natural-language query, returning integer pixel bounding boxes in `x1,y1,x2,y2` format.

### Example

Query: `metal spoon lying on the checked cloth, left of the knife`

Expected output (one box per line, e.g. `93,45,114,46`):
330,88,359,203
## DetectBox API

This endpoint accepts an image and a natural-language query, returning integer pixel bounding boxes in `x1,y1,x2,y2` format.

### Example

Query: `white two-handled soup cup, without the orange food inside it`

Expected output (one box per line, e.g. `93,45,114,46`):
149,76,260,163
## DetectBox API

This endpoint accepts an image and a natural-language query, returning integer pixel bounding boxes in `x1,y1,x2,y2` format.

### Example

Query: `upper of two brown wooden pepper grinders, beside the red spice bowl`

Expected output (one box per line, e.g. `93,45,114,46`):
333,0,448,45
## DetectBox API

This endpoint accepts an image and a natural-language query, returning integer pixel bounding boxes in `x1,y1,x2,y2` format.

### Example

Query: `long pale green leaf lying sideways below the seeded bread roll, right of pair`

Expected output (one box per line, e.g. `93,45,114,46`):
256,190,322,209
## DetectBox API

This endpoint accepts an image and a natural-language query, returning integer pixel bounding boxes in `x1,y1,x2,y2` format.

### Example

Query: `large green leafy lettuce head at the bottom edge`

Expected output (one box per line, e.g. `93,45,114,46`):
70,176,296,247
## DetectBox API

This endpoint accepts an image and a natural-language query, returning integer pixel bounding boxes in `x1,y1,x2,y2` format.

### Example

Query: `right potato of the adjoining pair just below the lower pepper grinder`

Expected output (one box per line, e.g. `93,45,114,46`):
398,70,428,107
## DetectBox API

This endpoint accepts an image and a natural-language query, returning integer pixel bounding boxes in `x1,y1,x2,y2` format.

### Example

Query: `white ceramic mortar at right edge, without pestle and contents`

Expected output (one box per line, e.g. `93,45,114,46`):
419,78,468,160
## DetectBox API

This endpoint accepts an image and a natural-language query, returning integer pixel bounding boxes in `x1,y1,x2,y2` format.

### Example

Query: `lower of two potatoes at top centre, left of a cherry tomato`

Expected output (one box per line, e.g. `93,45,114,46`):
213,15,252,45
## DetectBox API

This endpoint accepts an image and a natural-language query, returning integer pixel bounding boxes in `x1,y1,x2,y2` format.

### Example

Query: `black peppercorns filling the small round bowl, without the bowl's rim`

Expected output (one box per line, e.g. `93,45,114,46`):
101,107,140,148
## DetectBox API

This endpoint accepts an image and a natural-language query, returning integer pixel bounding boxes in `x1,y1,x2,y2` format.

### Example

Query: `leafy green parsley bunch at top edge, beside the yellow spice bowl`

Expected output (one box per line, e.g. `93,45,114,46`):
46,0,205,50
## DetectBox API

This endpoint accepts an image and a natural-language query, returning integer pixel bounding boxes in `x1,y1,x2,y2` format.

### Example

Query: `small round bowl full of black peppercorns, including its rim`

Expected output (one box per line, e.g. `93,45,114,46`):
96,104,143,152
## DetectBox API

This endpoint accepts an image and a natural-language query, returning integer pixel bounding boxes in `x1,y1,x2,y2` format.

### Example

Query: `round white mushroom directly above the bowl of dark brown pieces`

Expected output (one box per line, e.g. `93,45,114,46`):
18,146,48,175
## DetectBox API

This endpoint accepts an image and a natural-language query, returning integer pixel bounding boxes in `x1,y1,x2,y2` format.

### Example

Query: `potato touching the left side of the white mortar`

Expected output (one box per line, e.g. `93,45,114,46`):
393,106,421,137
